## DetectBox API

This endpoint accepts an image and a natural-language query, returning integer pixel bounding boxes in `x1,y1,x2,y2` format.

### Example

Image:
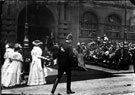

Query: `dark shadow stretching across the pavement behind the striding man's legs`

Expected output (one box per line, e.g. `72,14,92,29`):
1,66,120,89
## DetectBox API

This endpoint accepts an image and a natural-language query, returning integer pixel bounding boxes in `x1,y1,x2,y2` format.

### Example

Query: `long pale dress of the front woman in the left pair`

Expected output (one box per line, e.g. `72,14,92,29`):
2,51,23,87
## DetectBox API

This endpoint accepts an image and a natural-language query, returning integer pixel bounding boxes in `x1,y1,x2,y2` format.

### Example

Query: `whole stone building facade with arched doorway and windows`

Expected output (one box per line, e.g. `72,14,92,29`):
1,0,135,45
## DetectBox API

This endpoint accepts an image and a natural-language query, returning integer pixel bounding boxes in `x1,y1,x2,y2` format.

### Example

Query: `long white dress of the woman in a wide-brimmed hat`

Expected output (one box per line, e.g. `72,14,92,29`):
27,46,46,85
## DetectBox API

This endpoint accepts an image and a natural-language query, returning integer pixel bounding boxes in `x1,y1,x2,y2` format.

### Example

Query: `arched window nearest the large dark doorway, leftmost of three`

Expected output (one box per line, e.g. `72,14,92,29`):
79,12,98,38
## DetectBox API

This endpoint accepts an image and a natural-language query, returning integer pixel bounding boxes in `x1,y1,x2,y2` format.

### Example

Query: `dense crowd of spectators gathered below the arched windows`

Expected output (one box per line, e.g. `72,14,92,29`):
74,35,135,69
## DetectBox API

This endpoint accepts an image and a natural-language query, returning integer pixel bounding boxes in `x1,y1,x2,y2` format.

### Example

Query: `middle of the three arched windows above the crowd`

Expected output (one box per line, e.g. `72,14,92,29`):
105,14,121,39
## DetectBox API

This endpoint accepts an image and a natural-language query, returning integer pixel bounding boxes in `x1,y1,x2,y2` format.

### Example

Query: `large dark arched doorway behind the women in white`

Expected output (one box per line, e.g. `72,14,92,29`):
17,3,56,49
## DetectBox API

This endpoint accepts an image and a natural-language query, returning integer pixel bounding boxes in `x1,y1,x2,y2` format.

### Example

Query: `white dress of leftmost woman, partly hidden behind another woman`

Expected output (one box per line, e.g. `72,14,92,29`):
1,48,14,79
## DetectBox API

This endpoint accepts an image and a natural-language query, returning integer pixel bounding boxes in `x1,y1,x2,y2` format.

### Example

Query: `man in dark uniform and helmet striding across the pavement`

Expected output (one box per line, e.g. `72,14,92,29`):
51,34,75,94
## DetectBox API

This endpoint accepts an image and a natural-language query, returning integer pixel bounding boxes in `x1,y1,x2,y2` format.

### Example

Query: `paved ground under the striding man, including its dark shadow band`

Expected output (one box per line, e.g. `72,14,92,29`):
2,65,135,95
